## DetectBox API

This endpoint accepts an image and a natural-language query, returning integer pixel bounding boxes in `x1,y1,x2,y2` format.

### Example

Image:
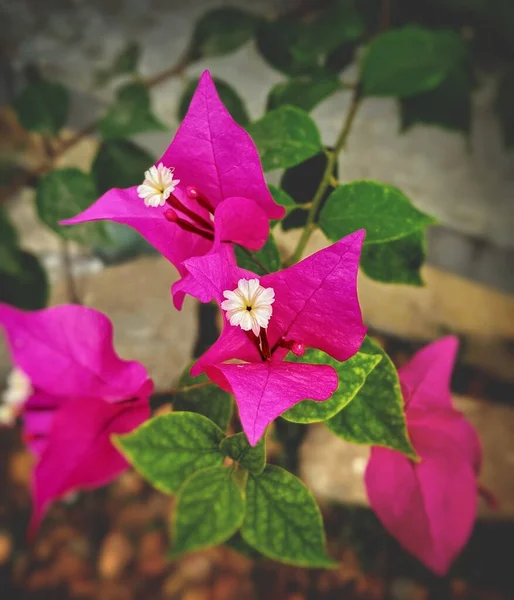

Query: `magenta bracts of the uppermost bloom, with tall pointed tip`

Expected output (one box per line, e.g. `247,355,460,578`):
62,71,285,309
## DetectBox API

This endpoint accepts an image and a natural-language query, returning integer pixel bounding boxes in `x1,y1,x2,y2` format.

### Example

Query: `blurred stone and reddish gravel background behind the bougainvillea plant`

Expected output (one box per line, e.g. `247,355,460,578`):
0,0,514,600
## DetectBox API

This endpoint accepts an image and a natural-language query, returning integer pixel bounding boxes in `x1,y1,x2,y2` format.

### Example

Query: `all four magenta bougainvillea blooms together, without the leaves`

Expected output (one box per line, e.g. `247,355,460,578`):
0,72,480,573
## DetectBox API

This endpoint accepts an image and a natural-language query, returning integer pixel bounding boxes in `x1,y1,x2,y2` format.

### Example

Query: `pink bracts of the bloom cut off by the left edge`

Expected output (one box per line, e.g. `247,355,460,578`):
0,304,153,534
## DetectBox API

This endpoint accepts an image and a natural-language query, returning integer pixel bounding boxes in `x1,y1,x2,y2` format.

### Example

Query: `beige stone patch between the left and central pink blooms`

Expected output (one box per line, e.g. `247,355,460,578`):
51,257,197,391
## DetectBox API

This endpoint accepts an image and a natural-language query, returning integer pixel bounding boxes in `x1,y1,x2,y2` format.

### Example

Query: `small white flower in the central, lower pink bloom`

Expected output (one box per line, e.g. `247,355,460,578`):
221,279,275,335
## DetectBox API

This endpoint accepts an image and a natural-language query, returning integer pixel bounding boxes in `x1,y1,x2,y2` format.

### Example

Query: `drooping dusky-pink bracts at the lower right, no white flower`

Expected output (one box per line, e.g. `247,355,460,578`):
365,337,481,575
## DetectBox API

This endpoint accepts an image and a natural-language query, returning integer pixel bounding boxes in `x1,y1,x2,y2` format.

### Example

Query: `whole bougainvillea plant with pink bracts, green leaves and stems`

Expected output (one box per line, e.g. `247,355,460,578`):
0,0,494,574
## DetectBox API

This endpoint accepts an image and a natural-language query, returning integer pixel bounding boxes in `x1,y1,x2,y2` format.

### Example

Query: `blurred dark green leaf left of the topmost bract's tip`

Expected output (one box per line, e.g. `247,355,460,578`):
98,83,166,140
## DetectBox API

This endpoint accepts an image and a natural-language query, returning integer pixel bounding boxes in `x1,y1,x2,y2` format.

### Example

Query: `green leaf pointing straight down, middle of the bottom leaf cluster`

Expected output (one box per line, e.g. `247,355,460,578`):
172,467,245,558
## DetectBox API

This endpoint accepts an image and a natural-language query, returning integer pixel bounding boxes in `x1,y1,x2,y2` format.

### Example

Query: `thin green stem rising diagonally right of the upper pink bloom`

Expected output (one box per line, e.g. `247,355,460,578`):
286,85,362,266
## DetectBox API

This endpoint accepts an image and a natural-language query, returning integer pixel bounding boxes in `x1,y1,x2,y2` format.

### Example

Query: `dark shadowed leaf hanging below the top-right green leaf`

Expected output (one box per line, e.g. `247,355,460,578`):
400,67,472,133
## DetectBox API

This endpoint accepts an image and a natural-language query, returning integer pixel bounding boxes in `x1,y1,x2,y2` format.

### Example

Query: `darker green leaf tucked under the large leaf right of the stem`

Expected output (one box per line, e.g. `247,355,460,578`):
360,231,426,287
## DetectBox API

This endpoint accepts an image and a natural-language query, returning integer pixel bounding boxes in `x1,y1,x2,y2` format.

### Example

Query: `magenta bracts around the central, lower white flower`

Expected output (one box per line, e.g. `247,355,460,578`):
186,231,366,445
